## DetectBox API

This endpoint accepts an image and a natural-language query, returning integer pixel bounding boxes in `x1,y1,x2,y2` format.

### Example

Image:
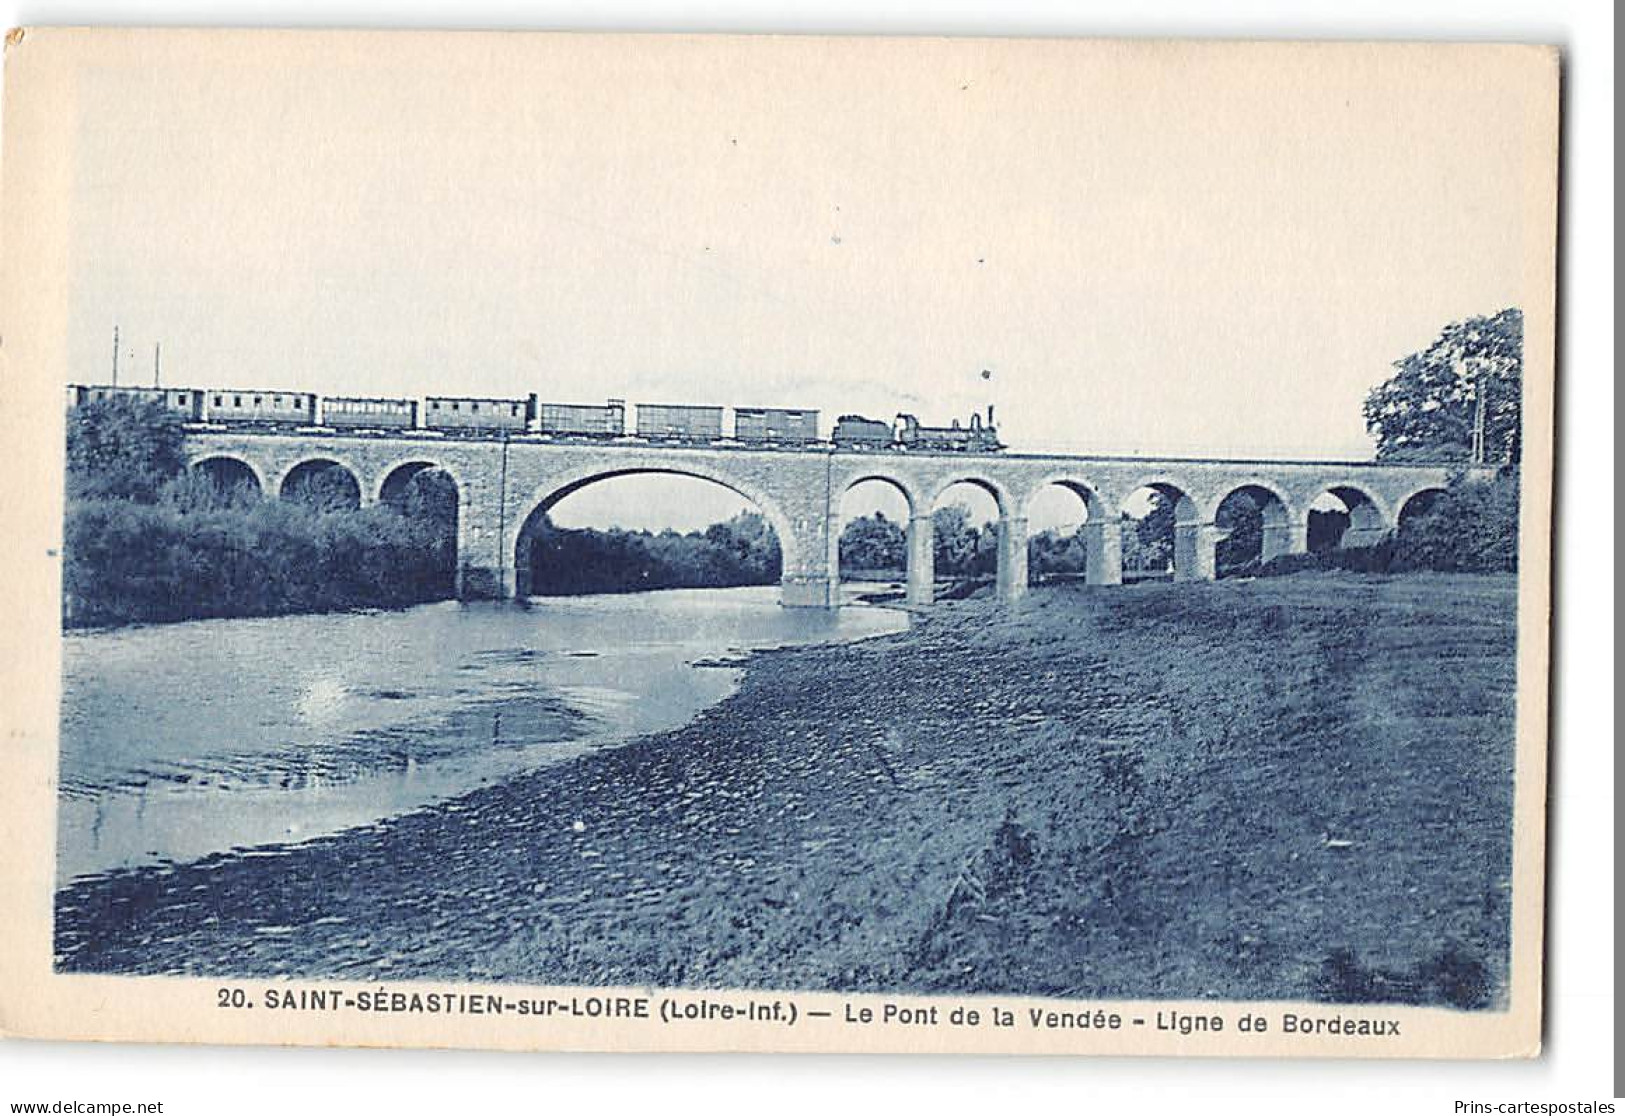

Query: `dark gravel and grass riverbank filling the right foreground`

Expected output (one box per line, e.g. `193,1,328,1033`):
57,573,1516,1007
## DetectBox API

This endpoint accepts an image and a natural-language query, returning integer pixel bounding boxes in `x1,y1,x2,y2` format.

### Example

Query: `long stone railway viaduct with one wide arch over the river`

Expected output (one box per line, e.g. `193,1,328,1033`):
185,430,1461,608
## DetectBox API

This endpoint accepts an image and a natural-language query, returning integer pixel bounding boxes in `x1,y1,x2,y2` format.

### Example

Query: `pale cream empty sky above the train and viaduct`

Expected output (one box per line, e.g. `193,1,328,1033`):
68,34,1542,526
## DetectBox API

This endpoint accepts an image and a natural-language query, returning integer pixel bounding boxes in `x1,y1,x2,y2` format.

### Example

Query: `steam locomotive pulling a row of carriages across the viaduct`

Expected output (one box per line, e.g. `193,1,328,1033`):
68,383,1004,453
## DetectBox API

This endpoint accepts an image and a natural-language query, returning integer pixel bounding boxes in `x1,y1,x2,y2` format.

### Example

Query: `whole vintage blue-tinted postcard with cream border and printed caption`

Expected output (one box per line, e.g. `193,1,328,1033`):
0,28,1558,1058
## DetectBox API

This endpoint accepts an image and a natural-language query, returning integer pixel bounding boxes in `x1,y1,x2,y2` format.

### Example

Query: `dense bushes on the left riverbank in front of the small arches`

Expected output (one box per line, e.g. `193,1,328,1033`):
63,396,457,625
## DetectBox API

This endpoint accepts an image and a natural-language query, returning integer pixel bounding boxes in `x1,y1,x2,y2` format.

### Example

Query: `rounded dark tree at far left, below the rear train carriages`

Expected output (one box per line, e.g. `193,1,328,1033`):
68,395,187,504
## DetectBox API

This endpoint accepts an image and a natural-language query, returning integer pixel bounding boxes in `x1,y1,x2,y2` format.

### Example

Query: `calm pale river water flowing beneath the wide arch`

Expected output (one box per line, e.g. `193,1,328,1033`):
57,586,907,882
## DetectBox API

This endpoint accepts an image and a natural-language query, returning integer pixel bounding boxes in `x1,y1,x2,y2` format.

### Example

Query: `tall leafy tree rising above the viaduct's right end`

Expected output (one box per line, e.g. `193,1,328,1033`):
1365,309,1523,465
